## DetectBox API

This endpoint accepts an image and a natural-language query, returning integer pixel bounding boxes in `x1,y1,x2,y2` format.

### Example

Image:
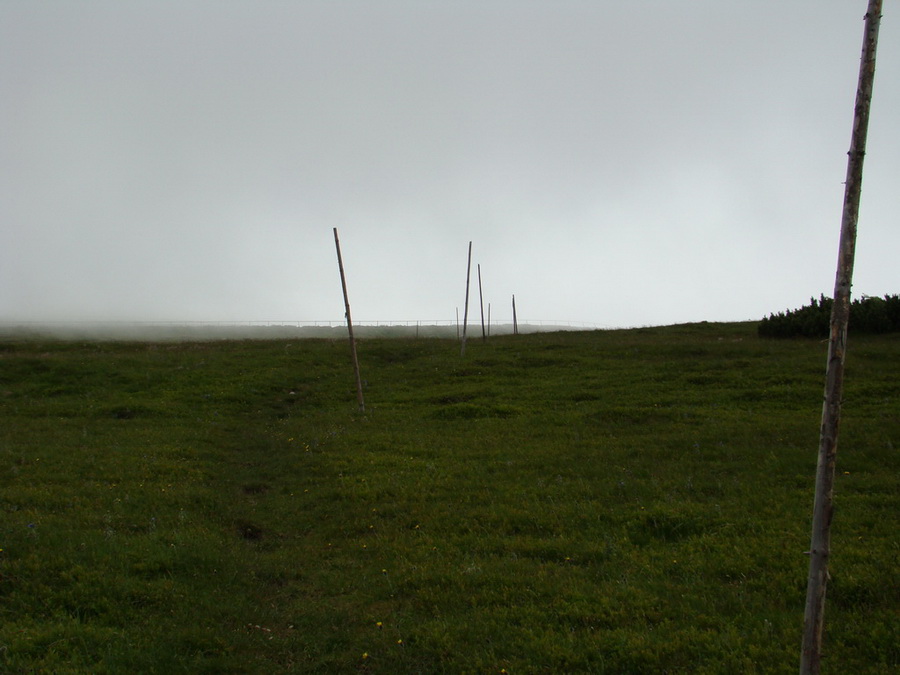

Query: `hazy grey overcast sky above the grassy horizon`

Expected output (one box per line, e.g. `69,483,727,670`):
0,0,900,326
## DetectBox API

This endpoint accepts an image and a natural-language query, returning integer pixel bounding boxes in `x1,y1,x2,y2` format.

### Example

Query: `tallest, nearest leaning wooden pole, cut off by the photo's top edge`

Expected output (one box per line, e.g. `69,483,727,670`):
800,0,882,675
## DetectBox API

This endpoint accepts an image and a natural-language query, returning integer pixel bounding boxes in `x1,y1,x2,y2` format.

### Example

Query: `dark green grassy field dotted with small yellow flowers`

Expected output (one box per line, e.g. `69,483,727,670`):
0,323,900,675
